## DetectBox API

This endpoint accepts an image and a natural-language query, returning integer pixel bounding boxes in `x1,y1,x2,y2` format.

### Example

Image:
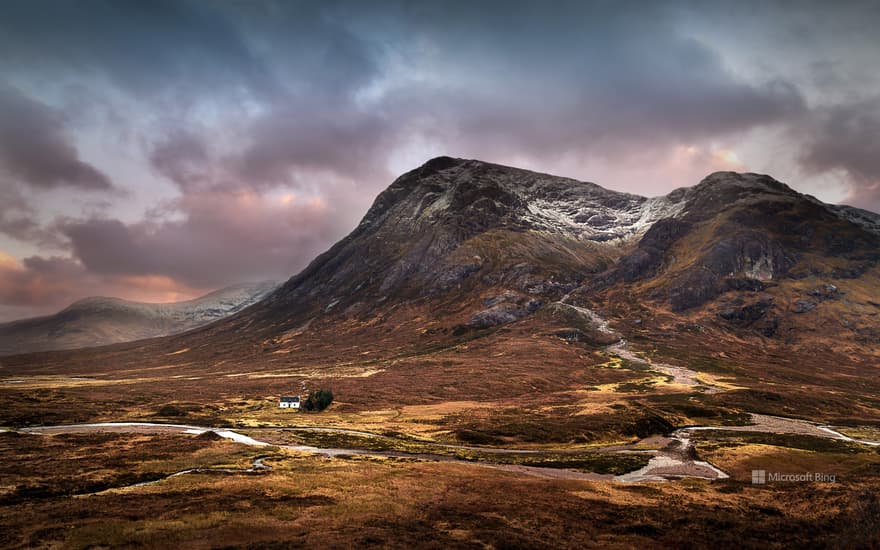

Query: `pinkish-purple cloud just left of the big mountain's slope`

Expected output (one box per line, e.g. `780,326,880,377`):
63,185,350,288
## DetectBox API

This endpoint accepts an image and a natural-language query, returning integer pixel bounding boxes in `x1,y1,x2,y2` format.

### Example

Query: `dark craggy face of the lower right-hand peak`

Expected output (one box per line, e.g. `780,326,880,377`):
618,172,880,311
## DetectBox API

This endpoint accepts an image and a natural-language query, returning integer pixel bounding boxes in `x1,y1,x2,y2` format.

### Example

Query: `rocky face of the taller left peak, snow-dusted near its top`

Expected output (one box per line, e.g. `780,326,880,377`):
258,157,683,328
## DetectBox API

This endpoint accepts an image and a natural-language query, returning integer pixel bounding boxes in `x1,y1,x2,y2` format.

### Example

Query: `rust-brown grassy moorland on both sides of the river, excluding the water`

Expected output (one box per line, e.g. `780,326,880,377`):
0,299,880,548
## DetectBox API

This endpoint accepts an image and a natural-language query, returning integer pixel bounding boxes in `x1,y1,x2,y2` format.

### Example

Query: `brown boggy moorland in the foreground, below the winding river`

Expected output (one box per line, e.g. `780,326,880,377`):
0,433,880,548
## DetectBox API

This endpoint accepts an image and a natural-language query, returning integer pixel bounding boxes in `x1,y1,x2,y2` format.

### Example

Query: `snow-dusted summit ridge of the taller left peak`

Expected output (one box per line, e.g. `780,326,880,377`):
364,157,684,242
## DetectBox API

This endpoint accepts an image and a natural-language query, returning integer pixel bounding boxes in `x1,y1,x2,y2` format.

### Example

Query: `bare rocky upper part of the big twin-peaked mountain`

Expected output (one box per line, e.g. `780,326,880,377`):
227,157,880,344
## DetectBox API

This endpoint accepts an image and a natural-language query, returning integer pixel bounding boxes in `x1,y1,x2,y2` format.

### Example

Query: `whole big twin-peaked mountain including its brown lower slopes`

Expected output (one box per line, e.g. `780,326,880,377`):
6,157,880,432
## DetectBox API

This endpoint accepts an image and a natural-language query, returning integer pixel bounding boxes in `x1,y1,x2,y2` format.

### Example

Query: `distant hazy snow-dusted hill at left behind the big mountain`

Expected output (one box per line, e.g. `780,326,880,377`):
0,281,278,355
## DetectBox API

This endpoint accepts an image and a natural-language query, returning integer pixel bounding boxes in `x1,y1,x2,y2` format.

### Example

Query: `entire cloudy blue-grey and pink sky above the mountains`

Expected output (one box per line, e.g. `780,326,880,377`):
0,0,880,321
